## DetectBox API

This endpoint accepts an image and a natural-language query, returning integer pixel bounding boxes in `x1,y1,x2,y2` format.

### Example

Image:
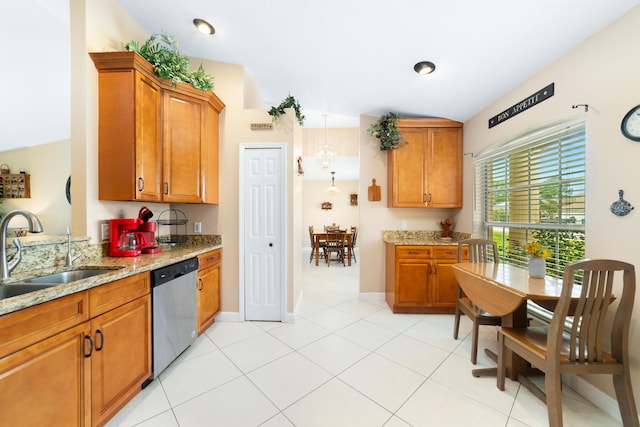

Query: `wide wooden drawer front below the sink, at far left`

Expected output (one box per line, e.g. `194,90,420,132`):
0,291,89,358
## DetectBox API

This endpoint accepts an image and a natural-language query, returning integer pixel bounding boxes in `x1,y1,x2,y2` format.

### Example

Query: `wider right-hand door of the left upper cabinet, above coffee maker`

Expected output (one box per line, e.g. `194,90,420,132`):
163,91,206,203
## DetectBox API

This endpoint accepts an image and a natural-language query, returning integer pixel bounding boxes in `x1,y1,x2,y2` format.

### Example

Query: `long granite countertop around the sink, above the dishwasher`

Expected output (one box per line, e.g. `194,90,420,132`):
0,242,222,315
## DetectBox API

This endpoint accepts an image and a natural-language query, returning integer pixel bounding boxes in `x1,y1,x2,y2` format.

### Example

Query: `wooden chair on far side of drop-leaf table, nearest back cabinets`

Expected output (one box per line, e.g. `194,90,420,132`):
453,239,502,364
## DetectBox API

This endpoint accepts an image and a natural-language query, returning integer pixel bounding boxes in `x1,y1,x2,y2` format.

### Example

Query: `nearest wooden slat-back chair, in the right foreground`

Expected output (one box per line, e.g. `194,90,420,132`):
498,260,638,427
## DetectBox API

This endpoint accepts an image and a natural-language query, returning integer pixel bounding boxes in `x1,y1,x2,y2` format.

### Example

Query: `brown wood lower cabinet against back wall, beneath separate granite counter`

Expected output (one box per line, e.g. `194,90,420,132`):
385,243,466,313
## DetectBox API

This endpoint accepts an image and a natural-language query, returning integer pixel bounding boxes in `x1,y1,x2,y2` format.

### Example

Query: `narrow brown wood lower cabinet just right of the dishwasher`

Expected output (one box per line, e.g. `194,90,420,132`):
198,249,222,335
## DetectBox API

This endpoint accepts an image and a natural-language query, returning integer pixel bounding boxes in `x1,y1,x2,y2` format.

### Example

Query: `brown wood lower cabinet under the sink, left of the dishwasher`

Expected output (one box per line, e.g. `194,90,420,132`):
0,273,151,426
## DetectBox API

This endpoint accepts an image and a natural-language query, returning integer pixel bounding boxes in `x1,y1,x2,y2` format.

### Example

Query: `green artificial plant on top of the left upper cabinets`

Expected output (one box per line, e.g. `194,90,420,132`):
124,32,213,90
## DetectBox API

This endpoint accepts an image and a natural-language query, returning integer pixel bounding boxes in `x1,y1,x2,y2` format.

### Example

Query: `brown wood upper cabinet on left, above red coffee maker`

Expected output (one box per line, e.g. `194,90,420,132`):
89,52,224,204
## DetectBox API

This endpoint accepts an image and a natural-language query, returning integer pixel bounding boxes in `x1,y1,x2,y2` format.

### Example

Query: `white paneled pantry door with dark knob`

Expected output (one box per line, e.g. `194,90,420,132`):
240,146,285,321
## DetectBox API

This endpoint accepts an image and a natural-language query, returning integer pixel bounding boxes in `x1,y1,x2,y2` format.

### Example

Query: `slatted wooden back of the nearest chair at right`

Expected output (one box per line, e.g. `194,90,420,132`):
547,260,636,363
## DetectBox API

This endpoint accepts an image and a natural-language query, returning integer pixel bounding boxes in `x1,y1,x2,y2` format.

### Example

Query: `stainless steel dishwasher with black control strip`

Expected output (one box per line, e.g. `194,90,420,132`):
151,258,198,378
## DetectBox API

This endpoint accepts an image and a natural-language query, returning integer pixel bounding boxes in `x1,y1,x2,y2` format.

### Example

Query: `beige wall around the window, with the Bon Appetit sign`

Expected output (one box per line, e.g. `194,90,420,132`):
456,7,640,414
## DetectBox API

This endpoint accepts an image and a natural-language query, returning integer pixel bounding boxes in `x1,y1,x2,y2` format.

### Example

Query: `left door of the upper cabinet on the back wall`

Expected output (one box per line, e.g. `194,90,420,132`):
387,129,427,208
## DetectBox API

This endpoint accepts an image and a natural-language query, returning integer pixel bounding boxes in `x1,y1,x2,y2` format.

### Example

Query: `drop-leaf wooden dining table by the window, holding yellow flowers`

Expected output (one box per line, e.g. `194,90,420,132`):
451,262,580,380
